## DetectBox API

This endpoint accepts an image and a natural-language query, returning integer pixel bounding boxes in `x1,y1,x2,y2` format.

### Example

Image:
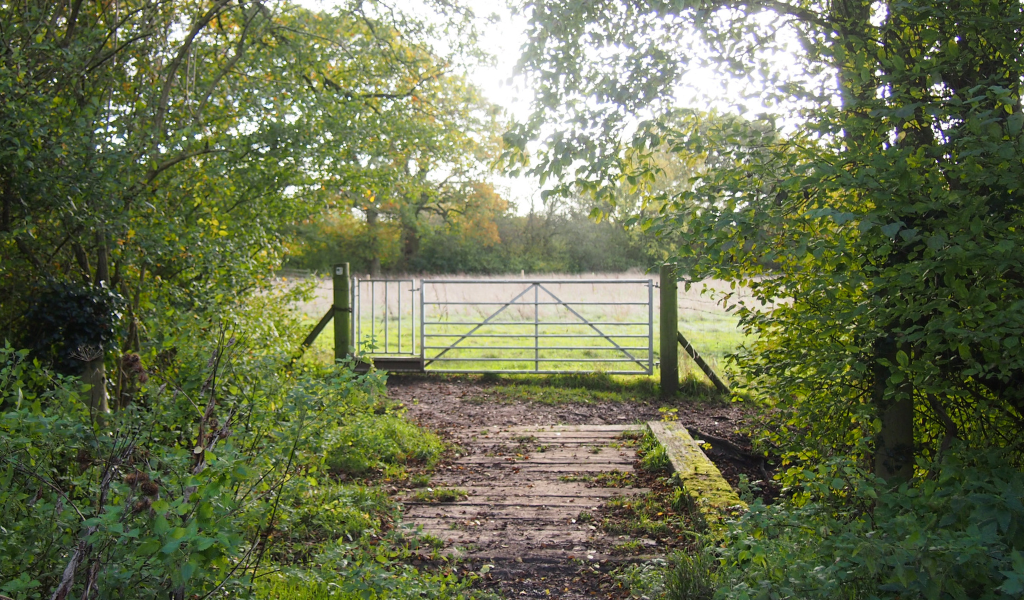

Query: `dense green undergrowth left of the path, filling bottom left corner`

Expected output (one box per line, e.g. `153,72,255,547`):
0,297,462,600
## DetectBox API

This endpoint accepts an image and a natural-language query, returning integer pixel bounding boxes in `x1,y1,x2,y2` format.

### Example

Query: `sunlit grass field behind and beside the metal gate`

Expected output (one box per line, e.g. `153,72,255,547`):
288,273,749,378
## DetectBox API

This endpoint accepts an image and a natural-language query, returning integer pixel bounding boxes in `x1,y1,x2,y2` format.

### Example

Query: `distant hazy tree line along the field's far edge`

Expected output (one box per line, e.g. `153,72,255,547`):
285,200,674,274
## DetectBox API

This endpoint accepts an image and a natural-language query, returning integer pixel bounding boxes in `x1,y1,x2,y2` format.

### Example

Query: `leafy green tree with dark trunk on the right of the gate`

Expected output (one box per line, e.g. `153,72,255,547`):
505,0,1024,470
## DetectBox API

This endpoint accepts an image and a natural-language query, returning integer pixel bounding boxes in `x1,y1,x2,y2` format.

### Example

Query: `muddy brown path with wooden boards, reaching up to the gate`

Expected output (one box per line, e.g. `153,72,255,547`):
388,377,774,600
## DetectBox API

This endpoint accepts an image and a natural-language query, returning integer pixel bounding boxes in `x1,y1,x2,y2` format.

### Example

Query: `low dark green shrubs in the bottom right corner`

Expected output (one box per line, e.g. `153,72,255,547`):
716,453,1024,600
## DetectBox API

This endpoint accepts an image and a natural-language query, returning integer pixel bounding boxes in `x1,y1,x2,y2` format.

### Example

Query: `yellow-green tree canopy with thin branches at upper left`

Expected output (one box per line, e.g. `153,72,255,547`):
0,0,490,337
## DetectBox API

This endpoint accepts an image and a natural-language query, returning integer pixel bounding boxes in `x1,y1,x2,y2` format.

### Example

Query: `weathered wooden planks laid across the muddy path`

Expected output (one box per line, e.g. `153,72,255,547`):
404,425,656,598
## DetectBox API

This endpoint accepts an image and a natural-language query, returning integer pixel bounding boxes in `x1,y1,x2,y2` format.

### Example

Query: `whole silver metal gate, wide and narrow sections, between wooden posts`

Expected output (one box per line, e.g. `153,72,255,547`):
351,278,654,375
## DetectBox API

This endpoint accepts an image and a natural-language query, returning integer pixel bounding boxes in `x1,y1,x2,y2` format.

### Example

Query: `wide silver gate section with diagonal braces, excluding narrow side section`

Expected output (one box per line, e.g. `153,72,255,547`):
420,280,654,375
